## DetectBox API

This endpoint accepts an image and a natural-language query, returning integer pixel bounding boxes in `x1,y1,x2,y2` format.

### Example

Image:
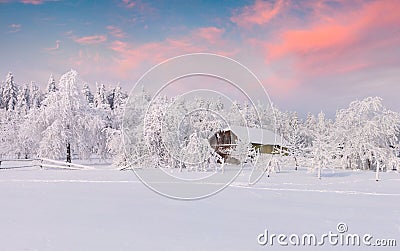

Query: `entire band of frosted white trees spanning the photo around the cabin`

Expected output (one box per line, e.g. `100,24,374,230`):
0,70,400,175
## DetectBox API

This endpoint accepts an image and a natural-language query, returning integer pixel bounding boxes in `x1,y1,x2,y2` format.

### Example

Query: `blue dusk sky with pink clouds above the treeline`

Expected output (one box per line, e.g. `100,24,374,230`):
0,0,400,115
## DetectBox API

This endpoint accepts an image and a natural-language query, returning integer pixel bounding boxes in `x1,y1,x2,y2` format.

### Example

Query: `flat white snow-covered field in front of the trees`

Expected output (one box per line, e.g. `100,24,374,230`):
0,164,400,251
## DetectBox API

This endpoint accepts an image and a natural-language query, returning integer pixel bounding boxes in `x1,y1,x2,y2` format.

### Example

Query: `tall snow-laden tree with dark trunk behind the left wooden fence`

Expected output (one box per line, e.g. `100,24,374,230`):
31,70,97,162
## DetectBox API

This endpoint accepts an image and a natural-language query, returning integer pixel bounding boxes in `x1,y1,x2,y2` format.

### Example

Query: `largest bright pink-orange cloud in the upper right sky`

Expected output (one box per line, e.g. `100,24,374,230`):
258,0,400,76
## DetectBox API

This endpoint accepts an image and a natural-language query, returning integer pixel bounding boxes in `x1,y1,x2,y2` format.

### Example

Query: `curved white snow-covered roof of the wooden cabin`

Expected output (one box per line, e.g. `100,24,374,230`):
224,126,287,146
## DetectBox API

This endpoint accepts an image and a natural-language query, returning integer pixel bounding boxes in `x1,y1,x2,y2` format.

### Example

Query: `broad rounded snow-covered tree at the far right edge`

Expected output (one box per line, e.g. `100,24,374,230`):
335,97,400,174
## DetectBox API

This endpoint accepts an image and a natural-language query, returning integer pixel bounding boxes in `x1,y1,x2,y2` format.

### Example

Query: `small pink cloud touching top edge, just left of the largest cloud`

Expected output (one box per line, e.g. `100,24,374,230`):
230,0,285,28
